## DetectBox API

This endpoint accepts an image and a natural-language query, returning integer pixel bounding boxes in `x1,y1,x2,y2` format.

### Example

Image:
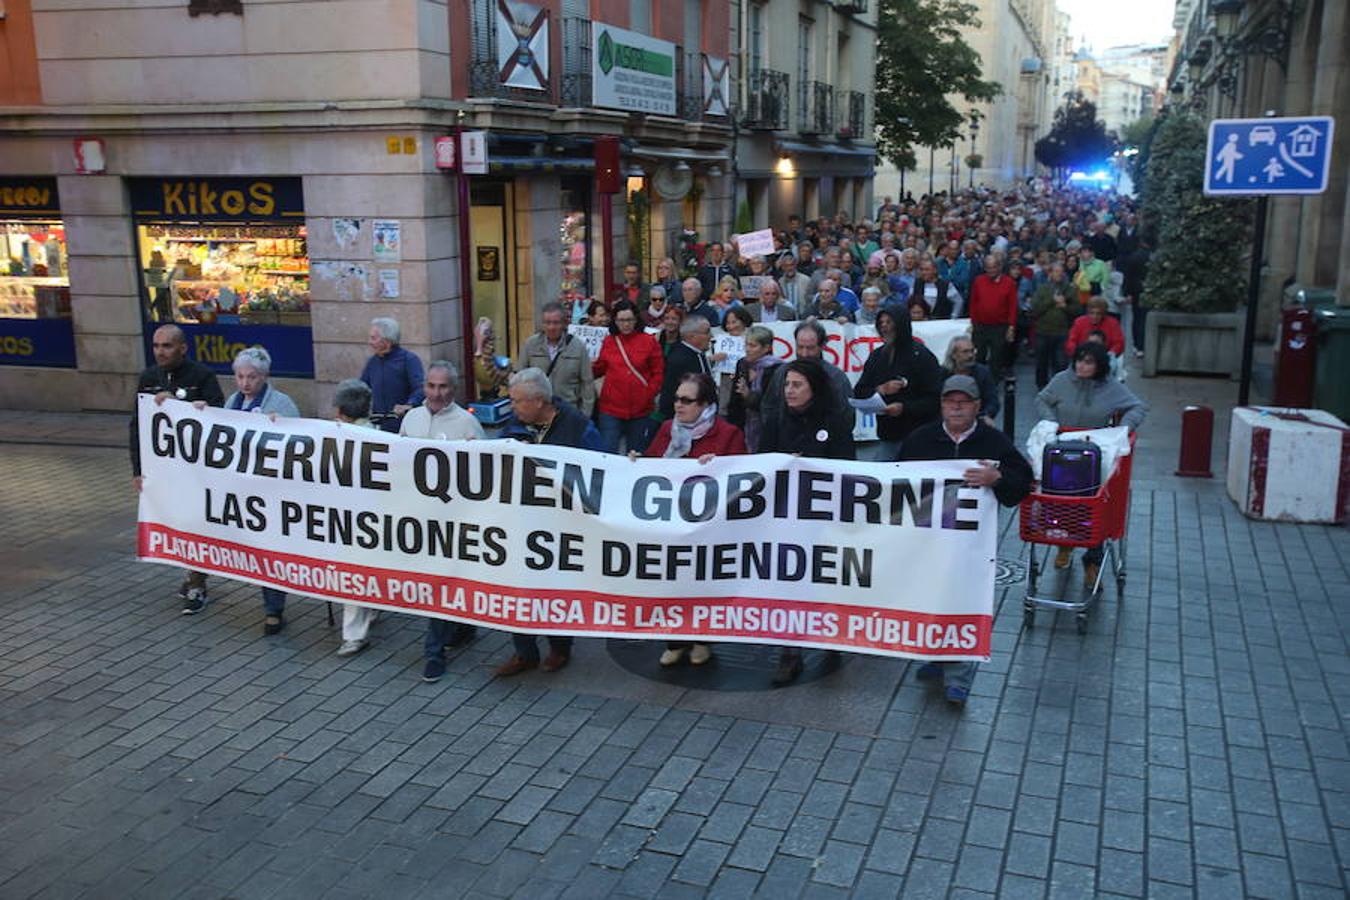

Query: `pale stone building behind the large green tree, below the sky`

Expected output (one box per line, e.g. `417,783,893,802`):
876,0,1067,196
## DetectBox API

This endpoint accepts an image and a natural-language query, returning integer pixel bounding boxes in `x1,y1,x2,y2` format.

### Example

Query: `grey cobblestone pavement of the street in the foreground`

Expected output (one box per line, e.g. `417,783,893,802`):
0,369,1350,900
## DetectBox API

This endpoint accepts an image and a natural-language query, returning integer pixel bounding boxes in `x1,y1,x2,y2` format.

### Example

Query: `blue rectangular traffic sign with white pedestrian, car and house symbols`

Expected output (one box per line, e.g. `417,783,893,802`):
1204,116,1335,196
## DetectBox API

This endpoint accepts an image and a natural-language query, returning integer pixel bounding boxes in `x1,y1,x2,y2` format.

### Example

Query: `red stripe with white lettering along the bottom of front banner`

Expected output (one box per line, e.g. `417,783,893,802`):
136,522,994,658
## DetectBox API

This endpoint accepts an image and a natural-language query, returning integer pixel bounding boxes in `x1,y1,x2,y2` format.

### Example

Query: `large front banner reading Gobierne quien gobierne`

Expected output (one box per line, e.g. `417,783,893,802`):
138,394,998,660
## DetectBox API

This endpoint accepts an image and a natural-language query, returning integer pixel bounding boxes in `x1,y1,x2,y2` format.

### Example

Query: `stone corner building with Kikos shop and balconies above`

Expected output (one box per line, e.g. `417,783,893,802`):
0,0,734,414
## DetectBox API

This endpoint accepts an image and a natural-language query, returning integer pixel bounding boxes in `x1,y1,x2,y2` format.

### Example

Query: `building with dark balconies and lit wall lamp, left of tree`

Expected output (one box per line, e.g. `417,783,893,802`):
733,0,876,228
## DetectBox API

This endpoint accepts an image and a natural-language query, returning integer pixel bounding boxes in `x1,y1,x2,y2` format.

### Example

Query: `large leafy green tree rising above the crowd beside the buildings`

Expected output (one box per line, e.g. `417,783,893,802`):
873,0,1003,170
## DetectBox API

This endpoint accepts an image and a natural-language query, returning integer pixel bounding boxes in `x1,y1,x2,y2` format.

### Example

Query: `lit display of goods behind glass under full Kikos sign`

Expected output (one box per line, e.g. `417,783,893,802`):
140,225,309,325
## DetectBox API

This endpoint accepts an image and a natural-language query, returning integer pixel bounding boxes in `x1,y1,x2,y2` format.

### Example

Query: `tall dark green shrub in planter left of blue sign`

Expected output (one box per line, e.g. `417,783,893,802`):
1139,111,1251,313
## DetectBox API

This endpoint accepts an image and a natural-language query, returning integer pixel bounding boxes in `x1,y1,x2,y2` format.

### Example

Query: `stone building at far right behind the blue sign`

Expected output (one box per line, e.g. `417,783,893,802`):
1169,0,1350,339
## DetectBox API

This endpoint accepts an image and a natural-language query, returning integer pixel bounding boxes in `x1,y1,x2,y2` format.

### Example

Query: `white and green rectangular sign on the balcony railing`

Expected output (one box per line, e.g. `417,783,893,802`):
591,22,675,116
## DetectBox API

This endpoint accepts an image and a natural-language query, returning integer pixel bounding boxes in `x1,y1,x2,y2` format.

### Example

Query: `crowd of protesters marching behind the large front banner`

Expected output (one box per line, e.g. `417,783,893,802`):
131,185,1149,704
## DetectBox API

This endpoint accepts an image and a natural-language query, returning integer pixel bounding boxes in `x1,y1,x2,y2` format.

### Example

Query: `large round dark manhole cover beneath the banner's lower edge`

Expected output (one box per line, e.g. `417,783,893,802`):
606,638,852,691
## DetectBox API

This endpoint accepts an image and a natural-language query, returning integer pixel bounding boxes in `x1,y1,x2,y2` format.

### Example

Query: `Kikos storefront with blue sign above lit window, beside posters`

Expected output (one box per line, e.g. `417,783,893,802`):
131,178,315,378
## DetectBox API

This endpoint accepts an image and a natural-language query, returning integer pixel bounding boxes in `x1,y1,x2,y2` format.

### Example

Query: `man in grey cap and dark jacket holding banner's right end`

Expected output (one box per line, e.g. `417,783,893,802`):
900,375,1033,707
